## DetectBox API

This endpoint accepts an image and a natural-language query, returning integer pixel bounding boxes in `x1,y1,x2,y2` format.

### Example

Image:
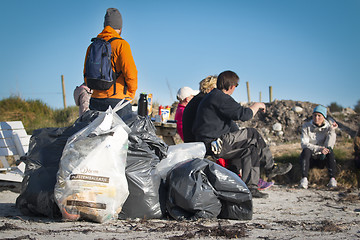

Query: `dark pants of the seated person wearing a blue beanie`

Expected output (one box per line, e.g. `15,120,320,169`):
300,148,336,178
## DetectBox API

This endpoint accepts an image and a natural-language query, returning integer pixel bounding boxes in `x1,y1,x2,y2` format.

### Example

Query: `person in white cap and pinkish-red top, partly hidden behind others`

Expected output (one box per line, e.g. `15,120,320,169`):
175,87,199,141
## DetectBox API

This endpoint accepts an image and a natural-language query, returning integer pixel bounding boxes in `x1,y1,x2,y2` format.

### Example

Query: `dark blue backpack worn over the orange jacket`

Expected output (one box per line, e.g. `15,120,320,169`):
84,37,121,94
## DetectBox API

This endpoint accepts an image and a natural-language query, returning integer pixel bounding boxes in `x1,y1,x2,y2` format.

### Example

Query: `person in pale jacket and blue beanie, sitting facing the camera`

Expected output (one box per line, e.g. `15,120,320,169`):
300,105,338,189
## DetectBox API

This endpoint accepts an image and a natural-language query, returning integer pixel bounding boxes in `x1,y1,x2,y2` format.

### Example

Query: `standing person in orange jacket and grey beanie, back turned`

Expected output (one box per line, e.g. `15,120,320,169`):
84,8,138,117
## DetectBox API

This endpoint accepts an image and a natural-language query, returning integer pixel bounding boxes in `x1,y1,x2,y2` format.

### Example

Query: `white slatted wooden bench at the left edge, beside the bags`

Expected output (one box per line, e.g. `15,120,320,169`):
0,121,31,182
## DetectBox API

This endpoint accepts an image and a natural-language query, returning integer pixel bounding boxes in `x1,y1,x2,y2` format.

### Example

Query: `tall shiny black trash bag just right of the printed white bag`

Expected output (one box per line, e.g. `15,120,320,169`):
119,116,168,219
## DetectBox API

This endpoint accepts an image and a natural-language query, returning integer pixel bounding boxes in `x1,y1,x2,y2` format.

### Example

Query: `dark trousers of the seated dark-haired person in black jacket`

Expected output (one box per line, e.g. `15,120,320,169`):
218,128,274,188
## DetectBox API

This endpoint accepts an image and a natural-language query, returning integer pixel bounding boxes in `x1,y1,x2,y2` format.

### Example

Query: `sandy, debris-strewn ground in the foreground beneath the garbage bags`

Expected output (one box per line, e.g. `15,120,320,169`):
0,185,360,240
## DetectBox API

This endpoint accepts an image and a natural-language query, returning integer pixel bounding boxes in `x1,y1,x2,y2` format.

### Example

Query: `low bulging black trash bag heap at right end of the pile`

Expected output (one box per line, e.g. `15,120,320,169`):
166,158,252,220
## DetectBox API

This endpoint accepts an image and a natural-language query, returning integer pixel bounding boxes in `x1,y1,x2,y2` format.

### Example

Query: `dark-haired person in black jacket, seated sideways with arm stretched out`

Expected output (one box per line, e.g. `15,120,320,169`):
192,71,292,198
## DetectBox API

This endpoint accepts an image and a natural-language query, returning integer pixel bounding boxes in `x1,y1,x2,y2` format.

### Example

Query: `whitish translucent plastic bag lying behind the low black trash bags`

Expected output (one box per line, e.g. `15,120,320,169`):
155,142,206,180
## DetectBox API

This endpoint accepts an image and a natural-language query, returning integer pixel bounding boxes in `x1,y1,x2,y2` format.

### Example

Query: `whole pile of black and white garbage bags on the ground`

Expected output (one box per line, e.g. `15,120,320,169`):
16,102,252,223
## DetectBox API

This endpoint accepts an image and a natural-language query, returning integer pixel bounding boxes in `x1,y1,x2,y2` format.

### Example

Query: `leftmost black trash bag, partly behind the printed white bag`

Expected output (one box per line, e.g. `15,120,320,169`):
16,111,98,218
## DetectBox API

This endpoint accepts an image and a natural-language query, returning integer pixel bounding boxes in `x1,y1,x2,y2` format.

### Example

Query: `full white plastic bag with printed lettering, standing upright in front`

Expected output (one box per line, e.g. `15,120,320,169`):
55,102,130,223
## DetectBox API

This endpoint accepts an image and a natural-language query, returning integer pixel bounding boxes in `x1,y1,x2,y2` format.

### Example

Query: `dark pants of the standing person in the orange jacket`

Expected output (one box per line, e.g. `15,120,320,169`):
89,98,132,118
